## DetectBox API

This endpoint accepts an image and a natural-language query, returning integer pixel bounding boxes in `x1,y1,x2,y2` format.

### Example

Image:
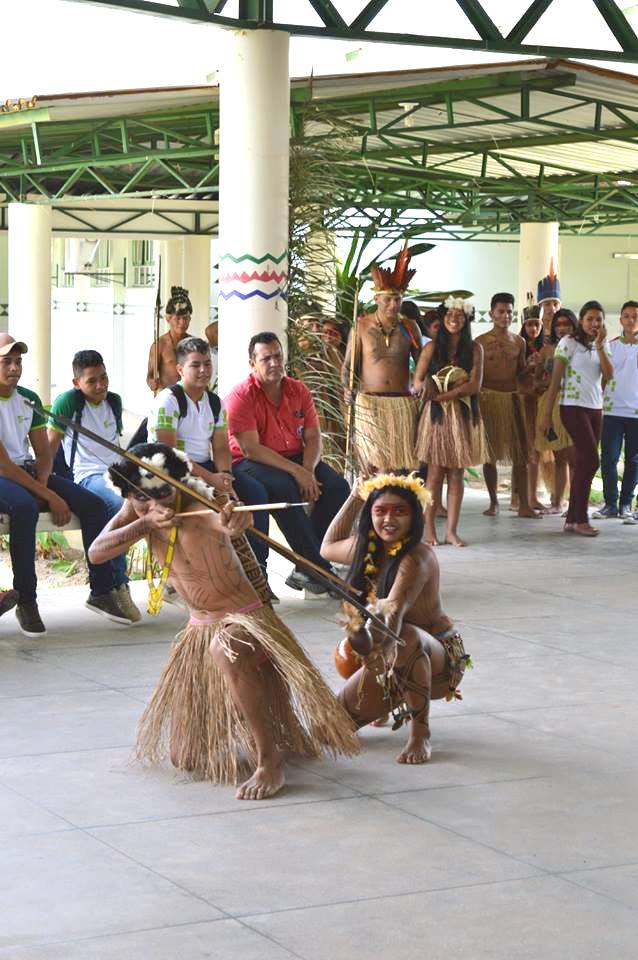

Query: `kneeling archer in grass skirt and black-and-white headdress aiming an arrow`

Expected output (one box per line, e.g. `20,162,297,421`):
91,443,358,800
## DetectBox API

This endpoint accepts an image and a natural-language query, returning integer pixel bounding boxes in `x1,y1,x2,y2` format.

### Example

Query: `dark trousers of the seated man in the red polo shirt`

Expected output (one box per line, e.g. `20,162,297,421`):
235,456,349,570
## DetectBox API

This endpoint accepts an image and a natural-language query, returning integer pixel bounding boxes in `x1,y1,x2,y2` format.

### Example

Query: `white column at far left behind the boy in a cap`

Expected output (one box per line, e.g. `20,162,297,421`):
9,203,51,403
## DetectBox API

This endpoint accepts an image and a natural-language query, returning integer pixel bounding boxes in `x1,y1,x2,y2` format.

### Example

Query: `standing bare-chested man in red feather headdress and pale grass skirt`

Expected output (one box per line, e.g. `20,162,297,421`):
342,241,421,476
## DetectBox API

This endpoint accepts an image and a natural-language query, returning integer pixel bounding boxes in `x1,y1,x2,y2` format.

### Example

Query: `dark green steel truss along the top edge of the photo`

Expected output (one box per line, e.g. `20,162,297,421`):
66,0,638,63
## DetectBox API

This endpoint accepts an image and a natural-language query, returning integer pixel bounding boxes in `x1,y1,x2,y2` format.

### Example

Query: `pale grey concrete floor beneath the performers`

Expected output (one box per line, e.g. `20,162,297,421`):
0,491,638,960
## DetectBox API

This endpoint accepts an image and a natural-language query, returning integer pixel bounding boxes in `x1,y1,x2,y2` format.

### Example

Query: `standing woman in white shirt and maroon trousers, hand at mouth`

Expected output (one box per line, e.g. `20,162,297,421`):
541,300,614,537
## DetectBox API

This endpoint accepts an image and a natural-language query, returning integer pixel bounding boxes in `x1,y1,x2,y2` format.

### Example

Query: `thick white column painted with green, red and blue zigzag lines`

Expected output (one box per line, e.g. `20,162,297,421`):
219,30,290,396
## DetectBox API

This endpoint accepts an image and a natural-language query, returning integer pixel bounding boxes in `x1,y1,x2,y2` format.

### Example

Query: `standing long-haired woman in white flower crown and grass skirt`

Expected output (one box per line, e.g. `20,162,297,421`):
413,297,487,547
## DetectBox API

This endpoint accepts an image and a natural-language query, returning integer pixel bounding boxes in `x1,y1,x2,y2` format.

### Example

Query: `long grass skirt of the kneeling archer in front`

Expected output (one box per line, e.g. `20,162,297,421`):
136,607,359,783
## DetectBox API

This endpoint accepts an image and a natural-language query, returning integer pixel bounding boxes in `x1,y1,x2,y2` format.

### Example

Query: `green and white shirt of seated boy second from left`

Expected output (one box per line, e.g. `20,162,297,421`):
48,390,122,483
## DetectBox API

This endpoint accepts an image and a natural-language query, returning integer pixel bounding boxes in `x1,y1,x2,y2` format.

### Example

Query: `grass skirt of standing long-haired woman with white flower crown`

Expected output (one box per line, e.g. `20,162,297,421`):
416,400,487,469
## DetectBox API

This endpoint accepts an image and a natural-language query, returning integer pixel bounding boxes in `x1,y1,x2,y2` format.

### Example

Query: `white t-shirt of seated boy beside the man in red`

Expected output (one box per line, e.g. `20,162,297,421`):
148,387,226,463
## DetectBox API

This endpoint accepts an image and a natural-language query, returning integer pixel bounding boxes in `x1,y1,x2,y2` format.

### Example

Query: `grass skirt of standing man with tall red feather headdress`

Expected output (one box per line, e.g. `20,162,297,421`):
354,393,419,475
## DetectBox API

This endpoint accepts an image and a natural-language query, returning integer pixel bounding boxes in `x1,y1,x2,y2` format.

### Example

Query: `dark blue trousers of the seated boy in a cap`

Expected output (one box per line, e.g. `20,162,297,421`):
0,474,115,603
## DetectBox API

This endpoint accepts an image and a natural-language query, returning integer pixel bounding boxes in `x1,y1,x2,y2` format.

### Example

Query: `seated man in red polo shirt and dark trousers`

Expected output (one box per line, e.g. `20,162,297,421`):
224,333,349,596
